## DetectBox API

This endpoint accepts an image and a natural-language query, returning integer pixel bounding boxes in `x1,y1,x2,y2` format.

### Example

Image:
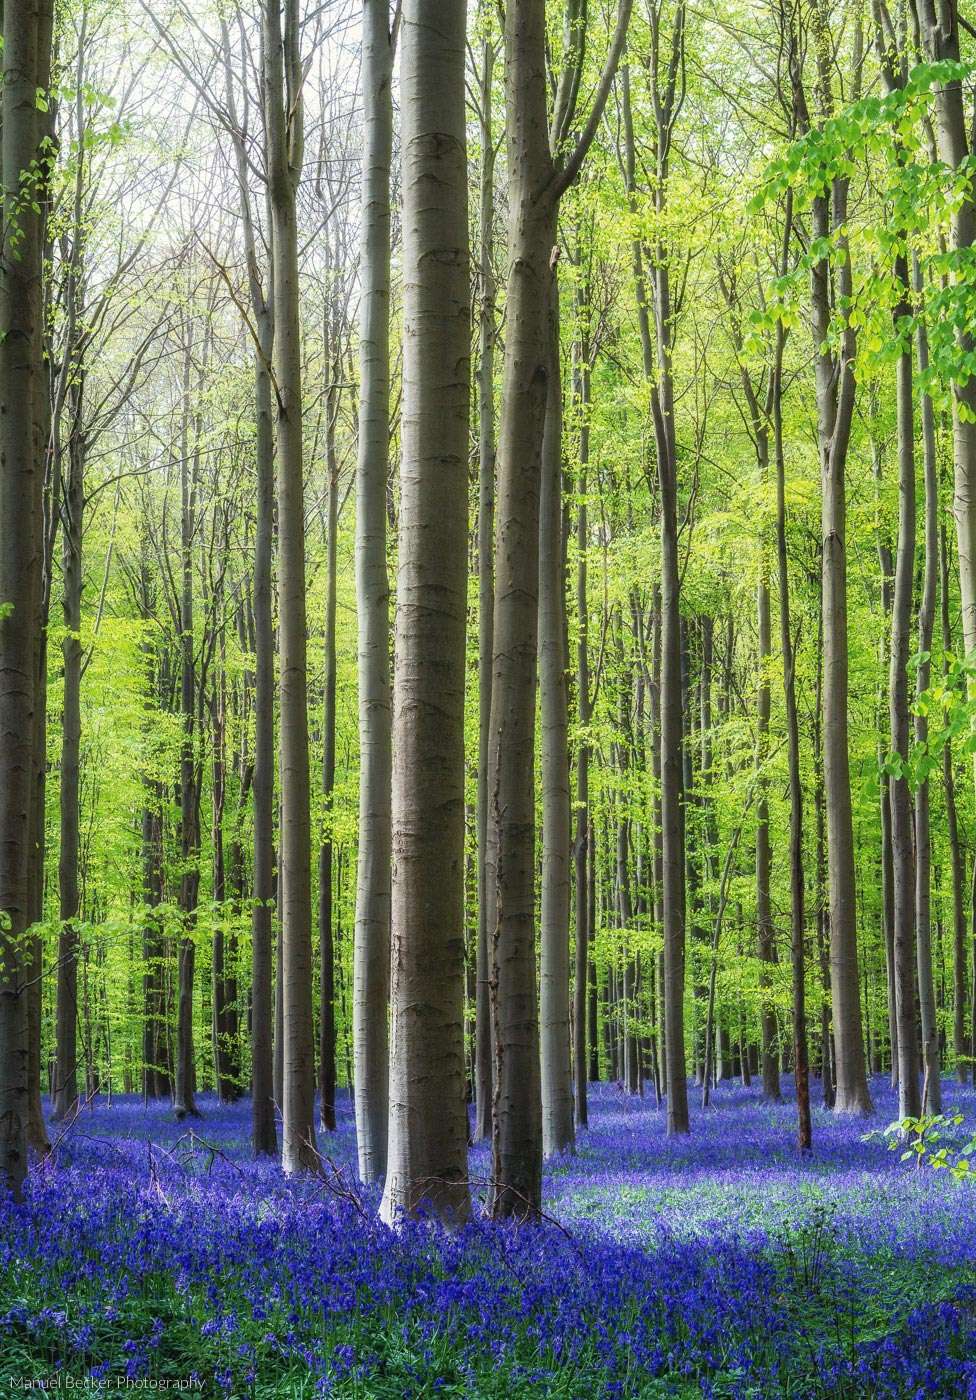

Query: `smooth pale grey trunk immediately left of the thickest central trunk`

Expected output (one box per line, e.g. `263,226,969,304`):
353,0,393,1182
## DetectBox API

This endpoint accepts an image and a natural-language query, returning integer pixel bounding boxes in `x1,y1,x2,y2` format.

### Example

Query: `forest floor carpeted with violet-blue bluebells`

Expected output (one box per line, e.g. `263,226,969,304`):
0,1079,976,1400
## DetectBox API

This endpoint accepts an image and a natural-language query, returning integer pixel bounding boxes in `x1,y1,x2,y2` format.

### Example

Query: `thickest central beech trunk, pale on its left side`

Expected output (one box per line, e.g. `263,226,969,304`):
381,0,470,1222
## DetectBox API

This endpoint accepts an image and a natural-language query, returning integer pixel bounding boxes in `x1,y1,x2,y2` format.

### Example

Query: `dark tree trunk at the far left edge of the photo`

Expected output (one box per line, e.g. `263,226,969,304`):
0,0,52,1198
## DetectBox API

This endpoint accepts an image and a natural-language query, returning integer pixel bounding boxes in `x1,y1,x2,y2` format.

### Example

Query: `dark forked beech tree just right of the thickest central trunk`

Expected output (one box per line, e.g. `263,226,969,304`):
487,0,630,1217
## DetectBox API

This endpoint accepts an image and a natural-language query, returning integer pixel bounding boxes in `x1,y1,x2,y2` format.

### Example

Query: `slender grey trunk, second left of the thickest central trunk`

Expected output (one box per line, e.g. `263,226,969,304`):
265,0,318,1173
